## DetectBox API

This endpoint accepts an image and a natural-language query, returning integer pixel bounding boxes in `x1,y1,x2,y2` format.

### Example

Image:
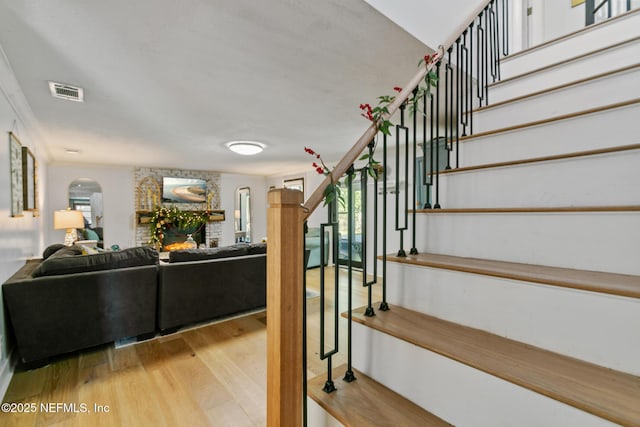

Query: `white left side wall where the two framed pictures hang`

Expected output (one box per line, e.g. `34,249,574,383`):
0,42,47,396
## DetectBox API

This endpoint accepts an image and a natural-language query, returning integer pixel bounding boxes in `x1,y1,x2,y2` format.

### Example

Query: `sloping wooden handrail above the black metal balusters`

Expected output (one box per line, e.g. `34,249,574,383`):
304,0,492,219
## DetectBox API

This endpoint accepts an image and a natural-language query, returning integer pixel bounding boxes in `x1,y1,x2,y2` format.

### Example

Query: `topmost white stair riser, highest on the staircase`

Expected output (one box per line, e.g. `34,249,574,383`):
500,13,640,79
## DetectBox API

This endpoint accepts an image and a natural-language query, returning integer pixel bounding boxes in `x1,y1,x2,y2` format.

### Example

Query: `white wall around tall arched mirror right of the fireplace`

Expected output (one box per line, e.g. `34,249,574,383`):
220,173,269,246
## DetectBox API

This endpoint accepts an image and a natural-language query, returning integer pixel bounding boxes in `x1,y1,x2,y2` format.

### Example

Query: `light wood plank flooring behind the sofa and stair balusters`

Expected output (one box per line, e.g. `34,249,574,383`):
0,268,381,427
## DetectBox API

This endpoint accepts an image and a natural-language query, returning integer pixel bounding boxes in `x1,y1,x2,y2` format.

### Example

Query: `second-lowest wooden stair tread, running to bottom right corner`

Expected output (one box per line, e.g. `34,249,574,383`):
352,306,640,426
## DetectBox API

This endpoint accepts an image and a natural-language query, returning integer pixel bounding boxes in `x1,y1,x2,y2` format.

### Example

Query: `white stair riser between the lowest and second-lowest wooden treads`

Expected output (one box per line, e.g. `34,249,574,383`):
352,324,613,427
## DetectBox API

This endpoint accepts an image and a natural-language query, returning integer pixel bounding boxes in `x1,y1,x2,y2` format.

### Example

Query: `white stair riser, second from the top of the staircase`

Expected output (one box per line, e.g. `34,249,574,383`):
489,42,640,104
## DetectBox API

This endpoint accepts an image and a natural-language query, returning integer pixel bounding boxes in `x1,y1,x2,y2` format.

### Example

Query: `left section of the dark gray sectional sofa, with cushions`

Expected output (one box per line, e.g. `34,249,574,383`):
2,248,158,363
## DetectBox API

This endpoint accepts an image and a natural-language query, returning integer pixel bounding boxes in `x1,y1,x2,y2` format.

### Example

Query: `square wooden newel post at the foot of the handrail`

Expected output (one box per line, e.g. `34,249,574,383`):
267,189,304,427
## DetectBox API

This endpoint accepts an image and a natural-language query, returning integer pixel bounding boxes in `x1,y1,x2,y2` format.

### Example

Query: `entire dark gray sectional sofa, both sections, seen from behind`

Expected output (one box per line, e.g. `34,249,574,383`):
2,244,266,365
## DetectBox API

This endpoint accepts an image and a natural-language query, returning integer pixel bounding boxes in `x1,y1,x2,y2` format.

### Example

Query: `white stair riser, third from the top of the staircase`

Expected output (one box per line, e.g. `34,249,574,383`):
473,67,640,132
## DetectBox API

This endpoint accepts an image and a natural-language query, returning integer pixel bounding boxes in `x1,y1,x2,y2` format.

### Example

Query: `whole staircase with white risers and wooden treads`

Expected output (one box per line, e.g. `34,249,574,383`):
308,10,640,427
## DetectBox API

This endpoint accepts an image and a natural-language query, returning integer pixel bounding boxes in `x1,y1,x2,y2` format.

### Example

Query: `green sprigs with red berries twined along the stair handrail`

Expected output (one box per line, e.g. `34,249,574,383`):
304,52,440,205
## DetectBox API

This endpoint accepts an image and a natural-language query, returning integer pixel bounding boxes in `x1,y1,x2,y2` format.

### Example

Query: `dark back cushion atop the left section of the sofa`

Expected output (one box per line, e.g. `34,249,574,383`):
33,246,158,277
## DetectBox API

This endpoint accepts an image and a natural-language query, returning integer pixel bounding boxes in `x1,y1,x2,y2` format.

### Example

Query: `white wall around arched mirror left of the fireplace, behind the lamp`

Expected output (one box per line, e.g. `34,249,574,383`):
48,163,135,248
